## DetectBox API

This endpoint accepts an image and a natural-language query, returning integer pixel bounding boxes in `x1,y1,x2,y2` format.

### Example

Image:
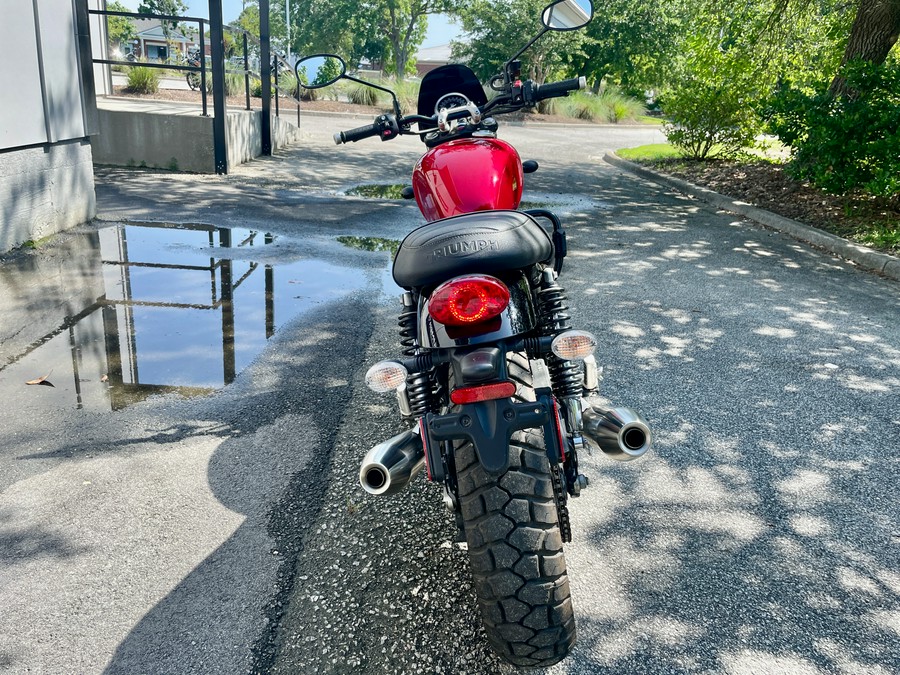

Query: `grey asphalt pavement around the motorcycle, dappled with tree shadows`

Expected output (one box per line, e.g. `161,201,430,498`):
0,116,900,675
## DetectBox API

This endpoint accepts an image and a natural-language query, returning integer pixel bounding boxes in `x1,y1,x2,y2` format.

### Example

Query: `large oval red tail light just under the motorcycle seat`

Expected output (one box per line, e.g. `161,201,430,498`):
428,274,509,326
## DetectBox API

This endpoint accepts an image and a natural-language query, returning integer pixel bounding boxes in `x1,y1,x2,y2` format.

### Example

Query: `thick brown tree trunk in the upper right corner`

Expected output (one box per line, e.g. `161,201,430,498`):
828,0,900,96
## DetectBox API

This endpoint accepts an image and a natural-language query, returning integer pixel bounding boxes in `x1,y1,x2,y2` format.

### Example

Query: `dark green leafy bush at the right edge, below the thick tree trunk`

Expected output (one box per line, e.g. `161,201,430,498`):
765,62,900,198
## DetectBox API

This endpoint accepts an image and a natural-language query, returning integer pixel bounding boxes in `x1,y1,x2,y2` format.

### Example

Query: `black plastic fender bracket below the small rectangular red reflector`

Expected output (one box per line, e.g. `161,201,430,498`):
425,395,559,474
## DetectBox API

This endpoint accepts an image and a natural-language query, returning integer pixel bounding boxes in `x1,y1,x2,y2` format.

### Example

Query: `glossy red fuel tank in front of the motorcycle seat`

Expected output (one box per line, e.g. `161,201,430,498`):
413,138,524,222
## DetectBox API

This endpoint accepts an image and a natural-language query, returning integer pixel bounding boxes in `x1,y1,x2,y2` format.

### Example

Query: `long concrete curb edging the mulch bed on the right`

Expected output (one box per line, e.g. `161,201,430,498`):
603,152,900,281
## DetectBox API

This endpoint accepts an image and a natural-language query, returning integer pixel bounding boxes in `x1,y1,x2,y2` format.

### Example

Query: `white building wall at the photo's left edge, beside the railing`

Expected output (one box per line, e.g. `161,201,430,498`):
0,0,100,251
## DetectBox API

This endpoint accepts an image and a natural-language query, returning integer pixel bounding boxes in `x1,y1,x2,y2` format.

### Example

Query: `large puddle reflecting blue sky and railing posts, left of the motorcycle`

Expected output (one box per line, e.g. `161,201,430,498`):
0,223,366,410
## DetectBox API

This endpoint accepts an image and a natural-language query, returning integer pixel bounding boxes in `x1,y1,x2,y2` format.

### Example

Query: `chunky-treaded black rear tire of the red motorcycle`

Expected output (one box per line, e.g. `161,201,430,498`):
454,355,575,667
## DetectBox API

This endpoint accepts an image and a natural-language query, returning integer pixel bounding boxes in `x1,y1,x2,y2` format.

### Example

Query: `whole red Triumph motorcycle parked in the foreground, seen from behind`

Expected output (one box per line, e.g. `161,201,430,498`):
296,0,651,667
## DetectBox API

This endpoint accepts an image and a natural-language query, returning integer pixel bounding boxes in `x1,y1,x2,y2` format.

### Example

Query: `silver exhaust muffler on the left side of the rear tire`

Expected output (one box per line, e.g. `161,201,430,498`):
359,431,425,495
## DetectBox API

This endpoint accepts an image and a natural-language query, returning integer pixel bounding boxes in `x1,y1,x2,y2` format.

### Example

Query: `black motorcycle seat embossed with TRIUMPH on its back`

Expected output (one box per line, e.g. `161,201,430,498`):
394,211,553,288
